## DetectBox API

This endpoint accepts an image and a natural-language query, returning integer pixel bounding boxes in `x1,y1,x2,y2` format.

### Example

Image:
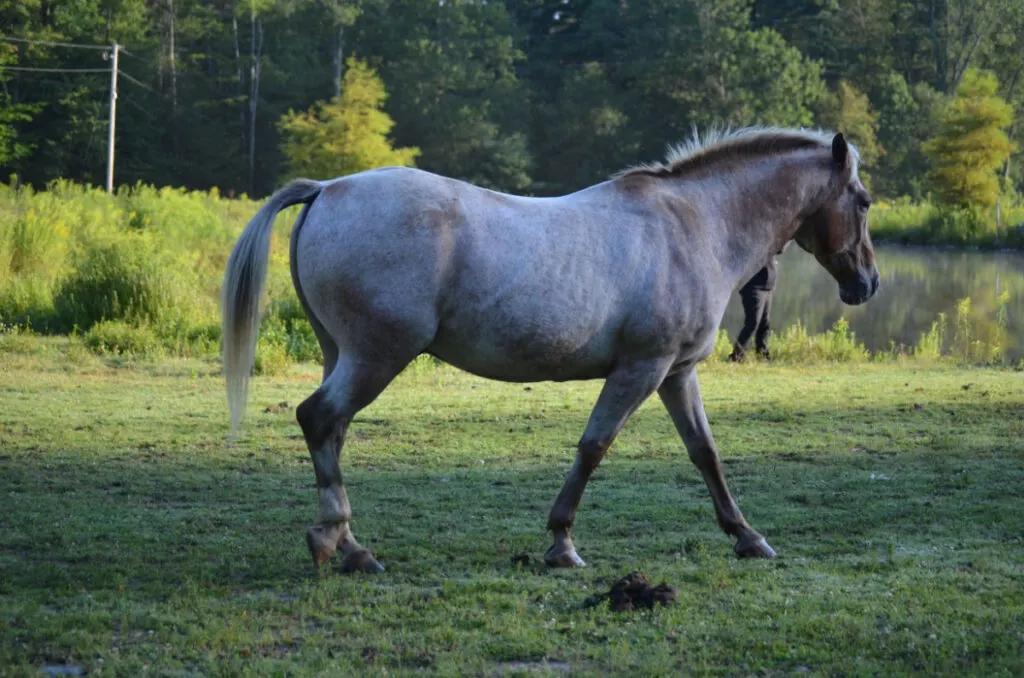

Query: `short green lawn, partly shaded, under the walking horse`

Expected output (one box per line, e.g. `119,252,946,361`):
0,337,1024,676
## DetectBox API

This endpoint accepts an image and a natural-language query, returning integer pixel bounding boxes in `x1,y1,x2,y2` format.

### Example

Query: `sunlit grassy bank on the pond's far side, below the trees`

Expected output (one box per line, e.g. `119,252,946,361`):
870,199,1024,250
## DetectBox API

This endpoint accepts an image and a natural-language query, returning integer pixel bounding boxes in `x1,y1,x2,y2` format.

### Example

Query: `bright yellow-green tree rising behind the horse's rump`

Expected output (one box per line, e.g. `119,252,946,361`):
279,58,420,178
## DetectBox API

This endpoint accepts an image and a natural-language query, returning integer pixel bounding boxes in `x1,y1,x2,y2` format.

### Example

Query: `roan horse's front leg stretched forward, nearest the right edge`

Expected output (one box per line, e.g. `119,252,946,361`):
657,368,775,558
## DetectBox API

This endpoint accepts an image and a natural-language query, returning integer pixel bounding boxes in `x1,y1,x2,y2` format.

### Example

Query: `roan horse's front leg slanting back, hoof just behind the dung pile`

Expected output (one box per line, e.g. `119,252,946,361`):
544,359,671,567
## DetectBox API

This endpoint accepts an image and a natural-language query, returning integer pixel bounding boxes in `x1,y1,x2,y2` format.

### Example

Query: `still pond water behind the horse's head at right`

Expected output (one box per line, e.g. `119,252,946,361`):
723,245,1024,362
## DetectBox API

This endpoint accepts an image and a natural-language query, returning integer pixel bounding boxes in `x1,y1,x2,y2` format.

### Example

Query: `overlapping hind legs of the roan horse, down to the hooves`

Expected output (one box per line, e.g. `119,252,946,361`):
296,355,408,573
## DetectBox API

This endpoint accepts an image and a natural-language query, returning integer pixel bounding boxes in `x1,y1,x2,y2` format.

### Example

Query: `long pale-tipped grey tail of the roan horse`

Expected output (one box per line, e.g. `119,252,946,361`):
221,179,323,435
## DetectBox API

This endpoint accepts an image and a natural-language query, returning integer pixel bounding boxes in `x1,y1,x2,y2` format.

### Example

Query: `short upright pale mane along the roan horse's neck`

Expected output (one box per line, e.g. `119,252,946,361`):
613,127,859,178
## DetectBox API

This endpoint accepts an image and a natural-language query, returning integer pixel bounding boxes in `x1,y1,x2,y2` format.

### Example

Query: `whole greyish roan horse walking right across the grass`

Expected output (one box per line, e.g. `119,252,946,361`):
223,128,879,571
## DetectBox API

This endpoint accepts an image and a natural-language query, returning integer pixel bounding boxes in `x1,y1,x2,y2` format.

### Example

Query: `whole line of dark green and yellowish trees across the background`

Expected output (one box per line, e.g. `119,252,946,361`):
0,0,1024,205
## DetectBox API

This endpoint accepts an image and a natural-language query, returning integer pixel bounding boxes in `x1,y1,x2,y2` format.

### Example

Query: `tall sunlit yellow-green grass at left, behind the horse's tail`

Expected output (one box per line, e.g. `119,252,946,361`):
0,181,299,359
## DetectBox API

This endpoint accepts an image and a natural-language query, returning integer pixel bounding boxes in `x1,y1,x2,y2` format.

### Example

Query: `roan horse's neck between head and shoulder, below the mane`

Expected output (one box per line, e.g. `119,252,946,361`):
684,158,826,288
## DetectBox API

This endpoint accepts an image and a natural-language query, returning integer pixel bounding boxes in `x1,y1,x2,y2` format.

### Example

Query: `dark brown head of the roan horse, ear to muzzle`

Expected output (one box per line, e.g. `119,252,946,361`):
795,134,879,305
